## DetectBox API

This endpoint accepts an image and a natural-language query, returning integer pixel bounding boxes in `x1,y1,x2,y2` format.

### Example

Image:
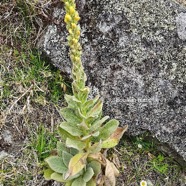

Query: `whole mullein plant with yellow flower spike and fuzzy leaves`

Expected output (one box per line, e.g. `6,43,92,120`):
44,0,127,186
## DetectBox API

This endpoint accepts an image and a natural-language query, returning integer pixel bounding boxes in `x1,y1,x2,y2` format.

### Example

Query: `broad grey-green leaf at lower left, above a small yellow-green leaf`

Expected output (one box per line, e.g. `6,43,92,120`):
45,156,67,174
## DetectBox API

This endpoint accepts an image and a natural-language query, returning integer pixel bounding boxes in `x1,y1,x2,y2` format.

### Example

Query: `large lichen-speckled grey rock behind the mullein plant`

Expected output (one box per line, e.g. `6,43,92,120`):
39,0,186,164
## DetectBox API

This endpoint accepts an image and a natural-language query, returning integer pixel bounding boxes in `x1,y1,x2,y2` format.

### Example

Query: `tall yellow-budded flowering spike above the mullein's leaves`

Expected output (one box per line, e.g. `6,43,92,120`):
63,0,86,99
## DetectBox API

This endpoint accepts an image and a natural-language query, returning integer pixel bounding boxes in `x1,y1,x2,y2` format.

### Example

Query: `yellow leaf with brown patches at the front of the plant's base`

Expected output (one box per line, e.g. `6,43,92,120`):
65,153,87,179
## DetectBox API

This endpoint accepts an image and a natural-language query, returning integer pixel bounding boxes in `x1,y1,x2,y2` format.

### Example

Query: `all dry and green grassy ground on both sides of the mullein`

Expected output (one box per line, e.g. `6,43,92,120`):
0,0,185,186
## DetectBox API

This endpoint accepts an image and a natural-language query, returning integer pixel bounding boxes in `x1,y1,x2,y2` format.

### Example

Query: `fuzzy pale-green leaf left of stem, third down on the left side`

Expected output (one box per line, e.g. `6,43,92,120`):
60,121,82,137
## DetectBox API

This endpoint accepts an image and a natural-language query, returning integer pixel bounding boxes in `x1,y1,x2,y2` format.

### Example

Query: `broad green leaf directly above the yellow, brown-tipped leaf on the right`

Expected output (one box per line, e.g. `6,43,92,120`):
98,119,119,140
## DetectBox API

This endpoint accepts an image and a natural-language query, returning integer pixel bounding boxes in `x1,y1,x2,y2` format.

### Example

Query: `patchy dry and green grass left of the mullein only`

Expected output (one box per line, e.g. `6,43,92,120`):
0,1,63,186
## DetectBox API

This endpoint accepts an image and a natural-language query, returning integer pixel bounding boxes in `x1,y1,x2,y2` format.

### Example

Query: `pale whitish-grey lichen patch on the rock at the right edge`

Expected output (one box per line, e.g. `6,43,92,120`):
176,12,186,40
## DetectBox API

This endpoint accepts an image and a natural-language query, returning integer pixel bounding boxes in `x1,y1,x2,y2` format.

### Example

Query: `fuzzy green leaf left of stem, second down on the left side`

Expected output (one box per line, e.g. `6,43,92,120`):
60,108,82,125
